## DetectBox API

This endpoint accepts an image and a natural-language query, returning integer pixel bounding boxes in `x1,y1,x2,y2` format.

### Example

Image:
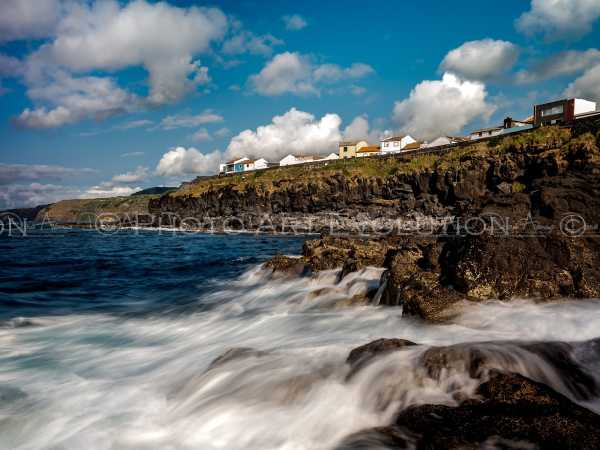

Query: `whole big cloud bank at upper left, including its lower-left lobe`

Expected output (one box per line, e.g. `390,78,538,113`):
12,0,228,128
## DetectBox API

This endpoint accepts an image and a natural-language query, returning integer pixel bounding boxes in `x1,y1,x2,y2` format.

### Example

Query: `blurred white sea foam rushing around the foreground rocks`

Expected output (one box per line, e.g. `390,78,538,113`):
0,268,600,450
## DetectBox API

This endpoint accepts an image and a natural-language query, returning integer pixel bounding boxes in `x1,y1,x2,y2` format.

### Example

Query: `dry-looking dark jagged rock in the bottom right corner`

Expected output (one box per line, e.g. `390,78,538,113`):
390,371,600,450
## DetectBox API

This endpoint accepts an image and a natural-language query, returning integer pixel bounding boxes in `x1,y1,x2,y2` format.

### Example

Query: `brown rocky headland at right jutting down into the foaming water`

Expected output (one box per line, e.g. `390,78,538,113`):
258,126,600,321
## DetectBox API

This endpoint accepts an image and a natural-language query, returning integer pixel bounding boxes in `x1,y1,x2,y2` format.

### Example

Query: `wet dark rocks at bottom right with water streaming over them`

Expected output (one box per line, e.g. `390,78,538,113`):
337,339,600,450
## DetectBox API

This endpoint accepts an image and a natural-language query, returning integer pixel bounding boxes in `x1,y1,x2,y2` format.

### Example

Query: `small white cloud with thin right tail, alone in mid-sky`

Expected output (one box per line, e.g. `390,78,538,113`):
249,52,374,96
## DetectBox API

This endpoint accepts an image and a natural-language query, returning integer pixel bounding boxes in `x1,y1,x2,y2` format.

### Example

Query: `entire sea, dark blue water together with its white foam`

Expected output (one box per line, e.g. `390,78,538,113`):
0,229,600,450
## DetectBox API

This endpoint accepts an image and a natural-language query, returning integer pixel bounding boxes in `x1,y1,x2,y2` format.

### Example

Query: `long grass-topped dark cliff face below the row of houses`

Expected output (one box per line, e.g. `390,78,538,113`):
149,128,597,232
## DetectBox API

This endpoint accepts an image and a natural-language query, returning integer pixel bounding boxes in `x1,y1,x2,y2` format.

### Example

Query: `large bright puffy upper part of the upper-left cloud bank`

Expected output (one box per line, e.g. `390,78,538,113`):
34,0,227,104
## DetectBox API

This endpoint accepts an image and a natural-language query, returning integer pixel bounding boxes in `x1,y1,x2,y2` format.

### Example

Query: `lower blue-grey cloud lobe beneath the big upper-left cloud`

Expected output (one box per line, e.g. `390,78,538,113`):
14,72,138,128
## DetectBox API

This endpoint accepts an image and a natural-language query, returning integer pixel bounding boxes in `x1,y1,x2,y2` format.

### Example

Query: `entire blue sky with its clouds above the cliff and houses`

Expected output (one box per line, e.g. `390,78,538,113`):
0,0,600,208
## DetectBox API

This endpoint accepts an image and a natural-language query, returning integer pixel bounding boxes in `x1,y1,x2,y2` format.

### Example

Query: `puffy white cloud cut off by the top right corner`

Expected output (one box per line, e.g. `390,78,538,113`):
516,0,600,40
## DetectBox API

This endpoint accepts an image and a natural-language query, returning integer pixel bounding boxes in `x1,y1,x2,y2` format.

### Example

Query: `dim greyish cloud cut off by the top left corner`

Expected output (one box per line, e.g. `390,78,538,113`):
0,0,61,42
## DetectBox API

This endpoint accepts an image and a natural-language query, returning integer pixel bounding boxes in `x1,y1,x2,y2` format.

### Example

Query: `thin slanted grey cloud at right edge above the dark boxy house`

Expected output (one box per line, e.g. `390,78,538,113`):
516,48,600,83
